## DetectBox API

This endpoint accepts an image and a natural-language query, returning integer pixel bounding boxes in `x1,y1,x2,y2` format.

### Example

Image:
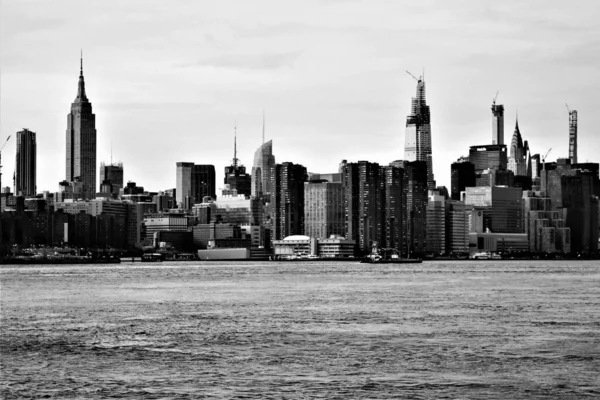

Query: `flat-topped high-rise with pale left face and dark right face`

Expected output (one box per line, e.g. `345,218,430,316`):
175,162,217,210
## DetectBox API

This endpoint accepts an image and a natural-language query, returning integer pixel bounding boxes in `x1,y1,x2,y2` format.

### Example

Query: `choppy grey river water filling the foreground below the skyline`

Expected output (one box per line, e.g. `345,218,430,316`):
0,261,600,399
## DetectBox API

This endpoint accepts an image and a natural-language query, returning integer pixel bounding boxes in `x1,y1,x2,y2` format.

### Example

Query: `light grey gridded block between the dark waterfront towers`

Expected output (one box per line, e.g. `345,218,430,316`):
304,181,346,238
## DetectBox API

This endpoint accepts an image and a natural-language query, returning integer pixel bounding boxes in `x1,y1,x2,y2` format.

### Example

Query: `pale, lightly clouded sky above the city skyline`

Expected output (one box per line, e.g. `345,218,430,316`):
0,0,600,192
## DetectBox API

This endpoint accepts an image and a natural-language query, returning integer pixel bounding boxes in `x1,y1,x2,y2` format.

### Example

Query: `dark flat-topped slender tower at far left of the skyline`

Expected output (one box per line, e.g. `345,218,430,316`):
15,129,37,197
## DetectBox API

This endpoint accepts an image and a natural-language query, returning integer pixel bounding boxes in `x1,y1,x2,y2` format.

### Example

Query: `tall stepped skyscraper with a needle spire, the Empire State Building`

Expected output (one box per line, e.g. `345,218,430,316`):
66,58,96,199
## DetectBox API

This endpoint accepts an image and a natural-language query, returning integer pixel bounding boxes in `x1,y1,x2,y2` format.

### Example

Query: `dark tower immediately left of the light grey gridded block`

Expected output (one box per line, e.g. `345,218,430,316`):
271,162,308,240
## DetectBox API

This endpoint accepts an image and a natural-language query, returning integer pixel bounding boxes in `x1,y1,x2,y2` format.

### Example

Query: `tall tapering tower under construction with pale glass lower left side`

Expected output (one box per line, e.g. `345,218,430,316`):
404,77,436,190
